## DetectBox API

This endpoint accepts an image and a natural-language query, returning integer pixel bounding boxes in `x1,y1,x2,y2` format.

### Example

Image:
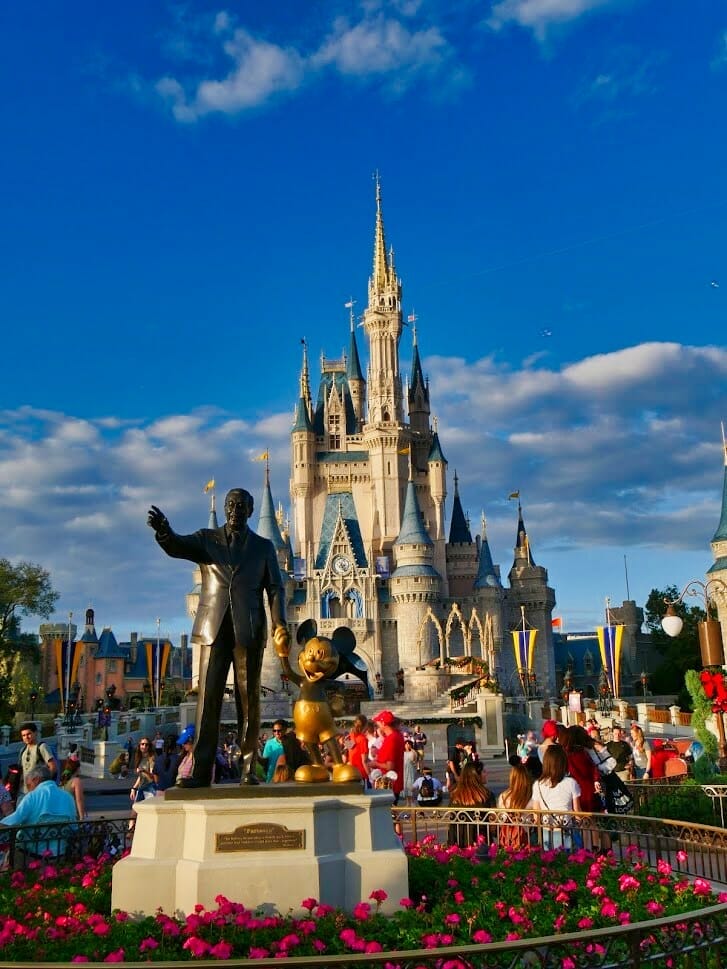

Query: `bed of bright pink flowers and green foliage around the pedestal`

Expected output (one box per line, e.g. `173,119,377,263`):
0,839,727,969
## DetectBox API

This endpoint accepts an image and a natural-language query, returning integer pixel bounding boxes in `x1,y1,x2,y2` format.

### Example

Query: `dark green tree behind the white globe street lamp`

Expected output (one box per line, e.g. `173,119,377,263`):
644,585,706,707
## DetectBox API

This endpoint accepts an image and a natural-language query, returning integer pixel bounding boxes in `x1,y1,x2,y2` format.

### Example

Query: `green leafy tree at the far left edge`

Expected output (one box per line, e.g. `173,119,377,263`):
0,558,58,721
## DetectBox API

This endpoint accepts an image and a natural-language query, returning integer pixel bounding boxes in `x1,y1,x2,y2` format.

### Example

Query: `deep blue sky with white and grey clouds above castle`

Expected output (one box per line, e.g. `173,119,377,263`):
0,0,727,638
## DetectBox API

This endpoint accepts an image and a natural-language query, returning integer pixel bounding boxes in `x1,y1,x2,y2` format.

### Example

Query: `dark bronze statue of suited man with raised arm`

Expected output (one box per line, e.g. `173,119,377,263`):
147,488,288,787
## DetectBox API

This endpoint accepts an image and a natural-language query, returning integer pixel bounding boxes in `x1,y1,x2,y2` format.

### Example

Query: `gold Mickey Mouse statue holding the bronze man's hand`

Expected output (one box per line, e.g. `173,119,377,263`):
273,619,361,784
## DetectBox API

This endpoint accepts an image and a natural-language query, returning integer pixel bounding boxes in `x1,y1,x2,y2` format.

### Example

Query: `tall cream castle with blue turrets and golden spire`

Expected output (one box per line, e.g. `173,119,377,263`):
252,179,556,699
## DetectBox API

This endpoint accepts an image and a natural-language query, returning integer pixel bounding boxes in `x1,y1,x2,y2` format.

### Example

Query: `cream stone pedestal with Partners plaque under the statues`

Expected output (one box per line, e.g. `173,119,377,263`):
111,783,409,915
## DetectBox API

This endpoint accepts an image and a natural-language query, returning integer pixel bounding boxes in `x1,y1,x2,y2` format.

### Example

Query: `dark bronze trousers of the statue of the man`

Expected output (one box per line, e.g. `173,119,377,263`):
192,610,264,784
